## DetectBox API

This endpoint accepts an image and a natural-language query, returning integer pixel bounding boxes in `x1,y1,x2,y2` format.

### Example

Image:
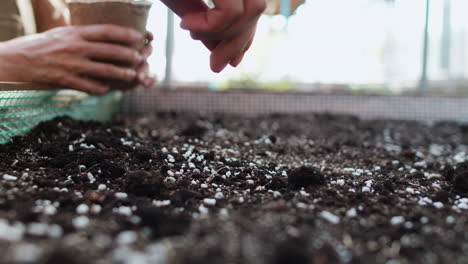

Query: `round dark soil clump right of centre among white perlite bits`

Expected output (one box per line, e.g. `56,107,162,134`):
287,166,325,189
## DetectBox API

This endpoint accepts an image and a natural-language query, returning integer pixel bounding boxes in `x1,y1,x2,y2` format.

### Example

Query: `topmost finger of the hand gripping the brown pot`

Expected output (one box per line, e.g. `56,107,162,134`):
79,25,144,46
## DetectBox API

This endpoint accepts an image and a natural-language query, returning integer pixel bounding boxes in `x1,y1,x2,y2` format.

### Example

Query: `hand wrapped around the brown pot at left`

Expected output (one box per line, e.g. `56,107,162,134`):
0,25,148,94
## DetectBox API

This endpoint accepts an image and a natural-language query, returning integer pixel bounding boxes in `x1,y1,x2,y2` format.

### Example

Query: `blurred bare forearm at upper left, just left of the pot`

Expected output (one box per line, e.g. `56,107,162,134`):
31,0,67,32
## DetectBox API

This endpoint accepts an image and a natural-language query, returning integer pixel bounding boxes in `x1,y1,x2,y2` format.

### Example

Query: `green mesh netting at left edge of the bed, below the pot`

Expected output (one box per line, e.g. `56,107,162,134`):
0,90,122,144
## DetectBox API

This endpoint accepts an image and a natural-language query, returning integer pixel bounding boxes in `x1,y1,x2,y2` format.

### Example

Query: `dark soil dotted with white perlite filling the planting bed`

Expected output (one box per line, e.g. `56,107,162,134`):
0,113,468,264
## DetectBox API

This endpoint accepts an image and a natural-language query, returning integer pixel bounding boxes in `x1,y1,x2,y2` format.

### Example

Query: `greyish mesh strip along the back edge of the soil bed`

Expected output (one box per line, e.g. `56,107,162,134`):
124,88,468,123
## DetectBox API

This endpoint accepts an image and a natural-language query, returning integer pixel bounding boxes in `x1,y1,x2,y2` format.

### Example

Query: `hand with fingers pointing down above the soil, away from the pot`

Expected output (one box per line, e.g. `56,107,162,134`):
181,0,266,72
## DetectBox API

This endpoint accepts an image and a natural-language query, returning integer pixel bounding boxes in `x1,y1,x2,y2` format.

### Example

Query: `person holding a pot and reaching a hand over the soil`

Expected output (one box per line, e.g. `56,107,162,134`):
0,0,266,94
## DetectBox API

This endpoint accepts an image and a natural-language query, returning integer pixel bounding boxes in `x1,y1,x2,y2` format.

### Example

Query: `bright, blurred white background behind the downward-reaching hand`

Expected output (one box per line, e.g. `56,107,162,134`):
149,0,468,94
